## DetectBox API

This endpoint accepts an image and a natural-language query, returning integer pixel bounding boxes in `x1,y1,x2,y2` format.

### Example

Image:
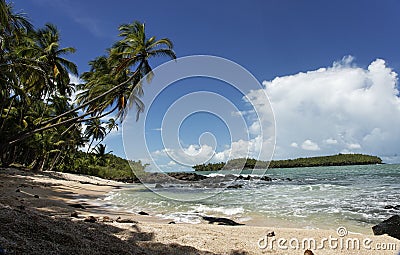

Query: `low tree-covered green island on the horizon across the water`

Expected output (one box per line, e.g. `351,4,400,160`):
193,154,382,171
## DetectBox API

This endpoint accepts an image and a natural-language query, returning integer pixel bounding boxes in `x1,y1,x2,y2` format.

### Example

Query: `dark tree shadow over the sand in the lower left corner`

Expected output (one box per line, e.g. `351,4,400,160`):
0,168,246,255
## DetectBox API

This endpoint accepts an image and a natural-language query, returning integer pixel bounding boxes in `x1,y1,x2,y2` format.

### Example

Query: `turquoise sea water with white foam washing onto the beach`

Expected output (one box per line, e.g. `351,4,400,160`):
106,165,400,232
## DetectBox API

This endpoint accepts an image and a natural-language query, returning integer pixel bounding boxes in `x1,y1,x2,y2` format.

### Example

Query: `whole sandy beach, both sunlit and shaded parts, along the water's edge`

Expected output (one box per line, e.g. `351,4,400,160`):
0,168,400,254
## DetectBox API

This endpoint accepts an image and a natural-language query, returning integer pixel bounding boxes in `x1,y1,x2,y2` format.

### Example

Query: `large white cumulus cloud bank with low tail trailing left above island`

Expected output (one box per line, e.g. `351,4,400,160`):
147,57,400,165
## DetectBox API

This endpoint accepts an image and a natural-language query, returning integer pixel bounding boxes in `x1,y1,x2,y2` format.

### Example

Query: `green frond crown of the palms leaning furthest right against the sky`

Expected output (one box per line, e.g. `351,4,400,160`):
78,21,176,121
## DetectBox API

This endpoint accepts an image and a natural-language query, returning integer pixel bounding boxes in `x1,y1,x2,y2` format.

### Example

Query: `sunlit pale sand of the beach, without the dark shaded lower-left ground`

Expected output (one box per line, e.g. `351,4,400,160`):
0,169,400,255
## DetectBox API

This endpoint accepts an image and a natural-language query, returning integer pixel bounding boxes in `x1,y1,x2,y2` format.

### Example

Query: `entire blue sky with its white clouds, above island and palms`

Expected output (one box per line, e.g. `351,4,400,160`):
14,0,400,170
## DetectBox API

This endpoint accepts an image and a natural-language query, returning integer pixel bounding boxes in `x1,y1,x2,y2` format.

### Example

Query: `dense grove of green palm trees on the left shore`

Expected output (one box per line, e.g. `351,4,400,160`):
0,0,176,177
